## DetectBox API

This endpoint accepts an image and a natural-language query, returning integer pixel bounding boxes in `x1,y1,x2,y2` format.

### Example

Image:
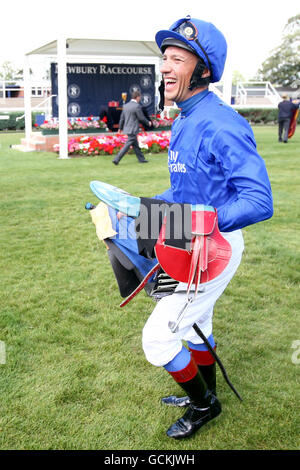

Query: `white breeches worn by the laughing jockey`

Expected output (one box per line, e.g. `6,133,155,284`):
142,230,244,367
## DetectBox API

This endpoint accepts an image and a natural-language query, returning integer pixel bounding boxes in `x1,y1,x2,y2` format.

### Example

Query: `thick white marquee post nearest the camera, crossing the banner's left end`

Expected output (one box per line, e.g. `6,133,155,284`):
57,36,68,158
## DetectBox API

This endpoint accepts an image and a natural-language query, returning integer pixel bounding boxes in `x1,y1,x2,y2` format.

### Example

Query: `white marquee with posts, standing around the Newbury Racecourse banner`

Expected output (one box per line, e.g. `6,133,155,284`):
24,36,231,158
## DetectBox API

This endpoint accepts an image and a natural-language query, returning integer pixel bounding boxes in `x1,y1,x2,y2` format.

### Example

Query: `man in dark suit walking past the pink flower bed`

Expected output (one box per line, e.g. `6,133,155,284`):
113,91,152,165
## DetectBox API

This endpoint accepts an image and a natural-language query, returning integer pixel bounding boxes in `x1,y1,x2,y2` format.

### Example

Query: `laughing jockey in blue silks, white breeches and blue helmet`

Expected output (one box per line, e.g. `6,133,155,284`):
143,17,273,439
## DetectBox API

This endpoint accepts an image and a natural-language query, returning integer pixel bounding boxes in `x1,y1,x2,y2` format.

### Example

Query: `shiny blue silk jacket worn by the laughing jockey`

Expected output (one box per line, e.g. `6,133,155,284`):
156,90,273,232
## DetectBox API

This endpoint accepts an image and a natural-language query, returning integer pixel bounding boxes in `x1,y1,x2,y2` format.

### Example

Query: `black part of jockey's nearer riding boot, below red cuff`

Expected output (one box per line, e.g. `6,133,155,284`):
167,371,221,439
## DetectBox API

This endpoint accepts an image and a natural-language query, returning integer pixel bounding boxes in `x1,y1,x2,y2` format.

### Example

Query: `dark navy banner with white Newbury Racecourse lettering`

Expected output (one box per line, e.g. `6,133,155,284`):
51,63,155,118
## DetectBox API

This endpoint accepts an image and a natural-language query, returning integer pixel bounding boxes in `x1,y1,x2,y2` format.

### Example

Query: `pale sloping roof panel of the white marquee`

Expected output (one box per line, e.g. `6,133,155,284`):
26,38,161,57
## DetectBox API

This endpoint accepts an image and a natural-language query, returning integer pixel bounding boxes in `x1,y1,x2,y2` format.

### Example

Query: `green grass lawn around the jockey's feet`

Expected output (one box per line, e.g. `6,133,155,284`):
0,127,300,450
